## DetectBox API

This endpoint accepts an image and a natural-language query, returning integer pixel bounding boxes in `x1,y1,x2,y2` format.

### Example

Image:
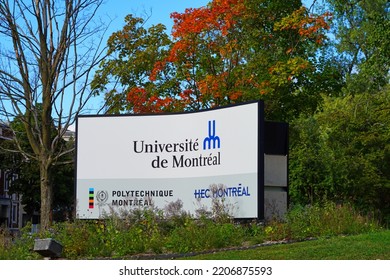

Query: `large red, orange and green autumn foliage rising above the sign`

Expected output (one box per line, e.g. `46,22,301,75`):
106,0,330,113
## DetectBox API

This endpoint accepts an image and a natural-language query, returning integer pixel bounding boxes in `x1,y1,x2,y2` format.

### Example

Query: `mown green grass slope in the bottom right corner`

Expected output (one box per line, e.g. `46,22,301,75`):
184,230,390,260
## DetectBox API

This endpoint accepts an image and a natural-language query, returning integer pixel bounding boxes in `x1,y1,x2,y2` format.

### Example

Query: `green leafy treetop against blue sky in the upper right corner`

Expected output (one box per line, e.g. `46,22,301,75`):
318,0,390,94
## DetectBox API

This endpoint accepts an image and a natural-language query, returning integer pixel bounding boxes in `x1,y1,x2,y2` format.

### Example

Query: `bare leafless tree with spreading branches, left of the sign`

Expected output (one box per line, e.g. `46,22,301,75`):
0,0,104,229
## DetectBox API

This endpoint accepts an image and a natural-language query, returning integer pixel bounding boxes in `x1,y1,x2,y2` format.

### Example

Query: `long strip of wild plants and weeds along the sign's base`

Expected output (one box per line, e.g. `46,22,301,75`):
0,202,380,259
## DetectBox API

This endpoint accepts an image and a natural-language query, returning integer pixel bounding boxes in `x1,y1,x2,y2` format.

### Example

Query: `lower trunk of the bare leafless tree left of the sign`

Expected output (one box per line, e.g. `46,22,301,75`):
40,160,53,230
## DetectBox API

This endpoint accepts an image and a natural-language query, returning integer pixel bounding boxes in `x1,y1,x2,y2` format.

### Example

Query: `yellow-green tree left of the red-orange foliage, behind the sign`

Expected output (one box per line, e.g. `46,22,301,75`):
92,15,178,114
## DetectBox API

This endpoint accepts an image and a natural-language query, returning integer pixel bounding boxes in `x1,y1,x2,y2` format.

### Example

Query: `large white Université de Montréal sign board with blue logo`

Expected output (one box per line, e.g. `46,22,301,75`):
76,102,264,219
